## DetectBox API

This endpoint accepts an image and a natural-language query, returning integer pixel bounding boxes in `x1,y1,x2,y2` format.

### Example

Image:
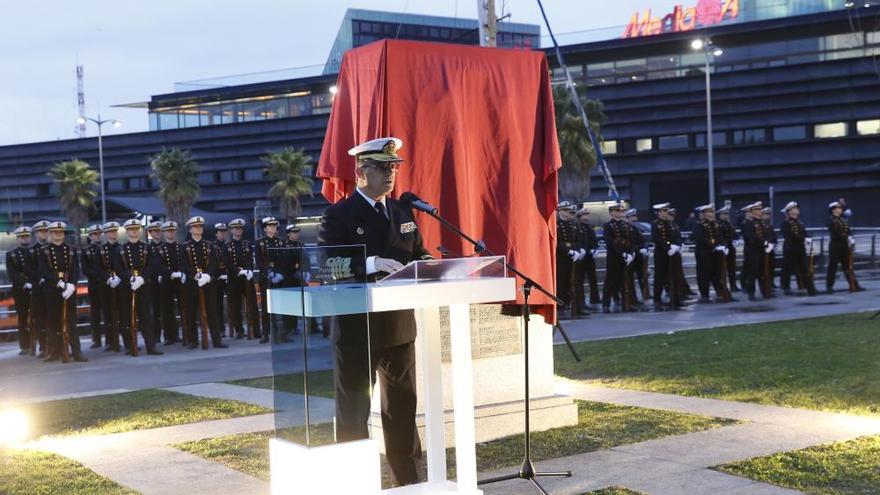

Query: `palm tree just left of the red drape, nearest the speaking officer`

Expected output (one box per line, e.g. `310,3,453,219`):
261,147,314,222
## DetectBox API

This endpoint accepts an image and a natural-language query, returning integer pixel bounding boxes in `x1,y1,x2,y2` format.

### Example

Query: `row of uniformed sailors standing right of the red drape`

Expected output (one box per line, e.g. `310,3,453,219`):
556,201,864,318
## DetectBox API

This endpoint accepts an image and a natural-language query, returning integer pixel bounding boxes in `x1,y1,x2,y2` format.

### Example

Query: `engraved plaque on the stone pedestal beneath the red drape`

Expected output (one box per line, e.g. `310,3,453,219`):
440,304,522,363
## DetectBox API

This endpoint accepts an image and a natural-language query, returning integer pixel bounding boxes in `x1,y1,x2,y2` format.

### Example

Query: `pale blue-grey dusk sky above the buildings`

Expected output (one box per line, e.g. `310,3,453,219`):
0,0,680,145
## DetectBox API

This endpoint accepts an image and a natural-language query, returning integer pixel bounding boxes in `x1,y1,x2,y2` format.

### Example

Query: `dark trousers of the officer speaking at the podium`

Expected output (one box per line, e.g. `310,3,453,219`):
334,342,422,485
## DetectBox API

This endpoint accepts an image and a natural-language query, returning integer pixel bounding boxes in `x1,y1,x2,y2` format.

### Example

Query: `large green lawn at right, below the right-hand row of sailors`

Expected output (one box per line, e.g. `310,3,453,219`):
555,313,880,415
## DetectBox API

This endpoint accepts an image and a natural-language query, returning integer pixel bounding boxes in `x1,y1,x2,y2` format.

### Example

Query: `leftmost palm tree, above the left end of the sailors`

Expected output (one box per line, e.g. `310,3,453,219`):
46,158,98,244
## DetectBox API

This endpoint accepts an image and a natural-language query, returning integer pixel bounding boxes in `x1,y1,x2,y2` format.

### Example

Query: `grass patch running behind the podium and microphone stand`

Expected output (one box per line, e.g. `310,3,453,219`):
174,401,735,486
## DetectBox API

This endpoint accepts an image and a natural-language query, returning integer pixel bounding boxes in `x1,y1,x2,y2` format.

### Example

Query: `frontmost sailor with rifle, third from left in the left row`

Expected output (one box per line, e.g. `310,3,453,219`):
38,222,88,362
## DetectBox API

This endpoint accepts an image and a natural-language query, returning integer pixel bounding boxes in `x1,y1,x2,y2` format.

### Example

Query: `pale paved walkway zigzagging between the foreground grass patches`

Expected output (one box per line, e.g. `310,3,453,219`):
24,380,880,495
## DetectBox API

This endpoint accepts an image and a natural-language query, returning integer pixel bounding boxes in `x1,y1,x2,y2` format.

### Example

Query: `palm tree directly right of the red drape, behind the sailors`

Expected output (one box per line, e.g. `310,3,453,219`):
553,86,605,200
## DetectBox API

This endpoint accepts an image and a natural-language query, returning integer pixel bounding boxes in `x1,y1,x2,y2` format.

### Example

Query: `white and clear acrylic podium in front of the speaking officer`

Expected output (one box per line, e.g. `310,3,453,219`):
268,246,516,495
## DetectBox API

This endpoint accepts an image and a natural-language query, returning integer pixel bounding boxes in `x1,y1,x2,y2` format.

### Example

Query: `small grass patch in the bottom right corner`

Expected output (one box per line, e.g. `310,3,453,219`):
715,436,880,495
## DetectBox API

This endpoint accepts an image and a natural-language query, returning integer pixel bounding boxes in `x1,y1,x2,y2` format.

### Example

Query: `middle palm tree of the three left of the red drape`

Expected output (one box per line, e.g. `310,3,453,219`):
150,148,200,236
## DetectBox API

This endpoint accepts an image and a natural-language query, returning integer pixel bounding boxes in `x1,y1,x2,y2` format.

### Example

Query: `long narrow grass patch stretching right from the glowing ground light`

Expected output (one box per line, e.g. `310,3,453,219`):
24,389,271,440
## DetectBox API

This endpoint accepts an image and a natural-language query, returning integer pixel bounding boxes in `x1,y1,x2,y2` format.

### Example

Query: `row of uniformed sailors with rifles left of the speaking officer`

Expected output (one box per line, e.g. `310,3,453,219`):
6,216,317,362
